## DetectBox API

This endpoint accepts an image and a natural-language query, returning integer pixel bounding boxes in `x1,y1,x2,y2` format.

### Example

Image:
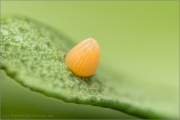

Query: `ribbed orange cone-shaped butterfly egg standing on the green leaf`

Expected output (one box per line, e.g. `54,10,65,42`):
66,38,100,77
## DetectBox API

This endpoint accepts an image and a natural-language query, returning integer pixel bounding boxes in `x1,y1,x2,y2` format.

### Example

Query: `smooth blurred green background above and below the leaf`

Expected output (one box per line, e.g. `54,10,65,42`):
1,1,179,118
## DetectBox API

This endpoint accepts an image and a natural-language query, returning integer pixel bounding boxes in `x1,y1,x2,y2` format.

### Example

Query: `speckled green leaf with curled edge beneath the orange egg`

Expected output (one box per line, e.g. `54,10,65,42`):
0,17,178,118
